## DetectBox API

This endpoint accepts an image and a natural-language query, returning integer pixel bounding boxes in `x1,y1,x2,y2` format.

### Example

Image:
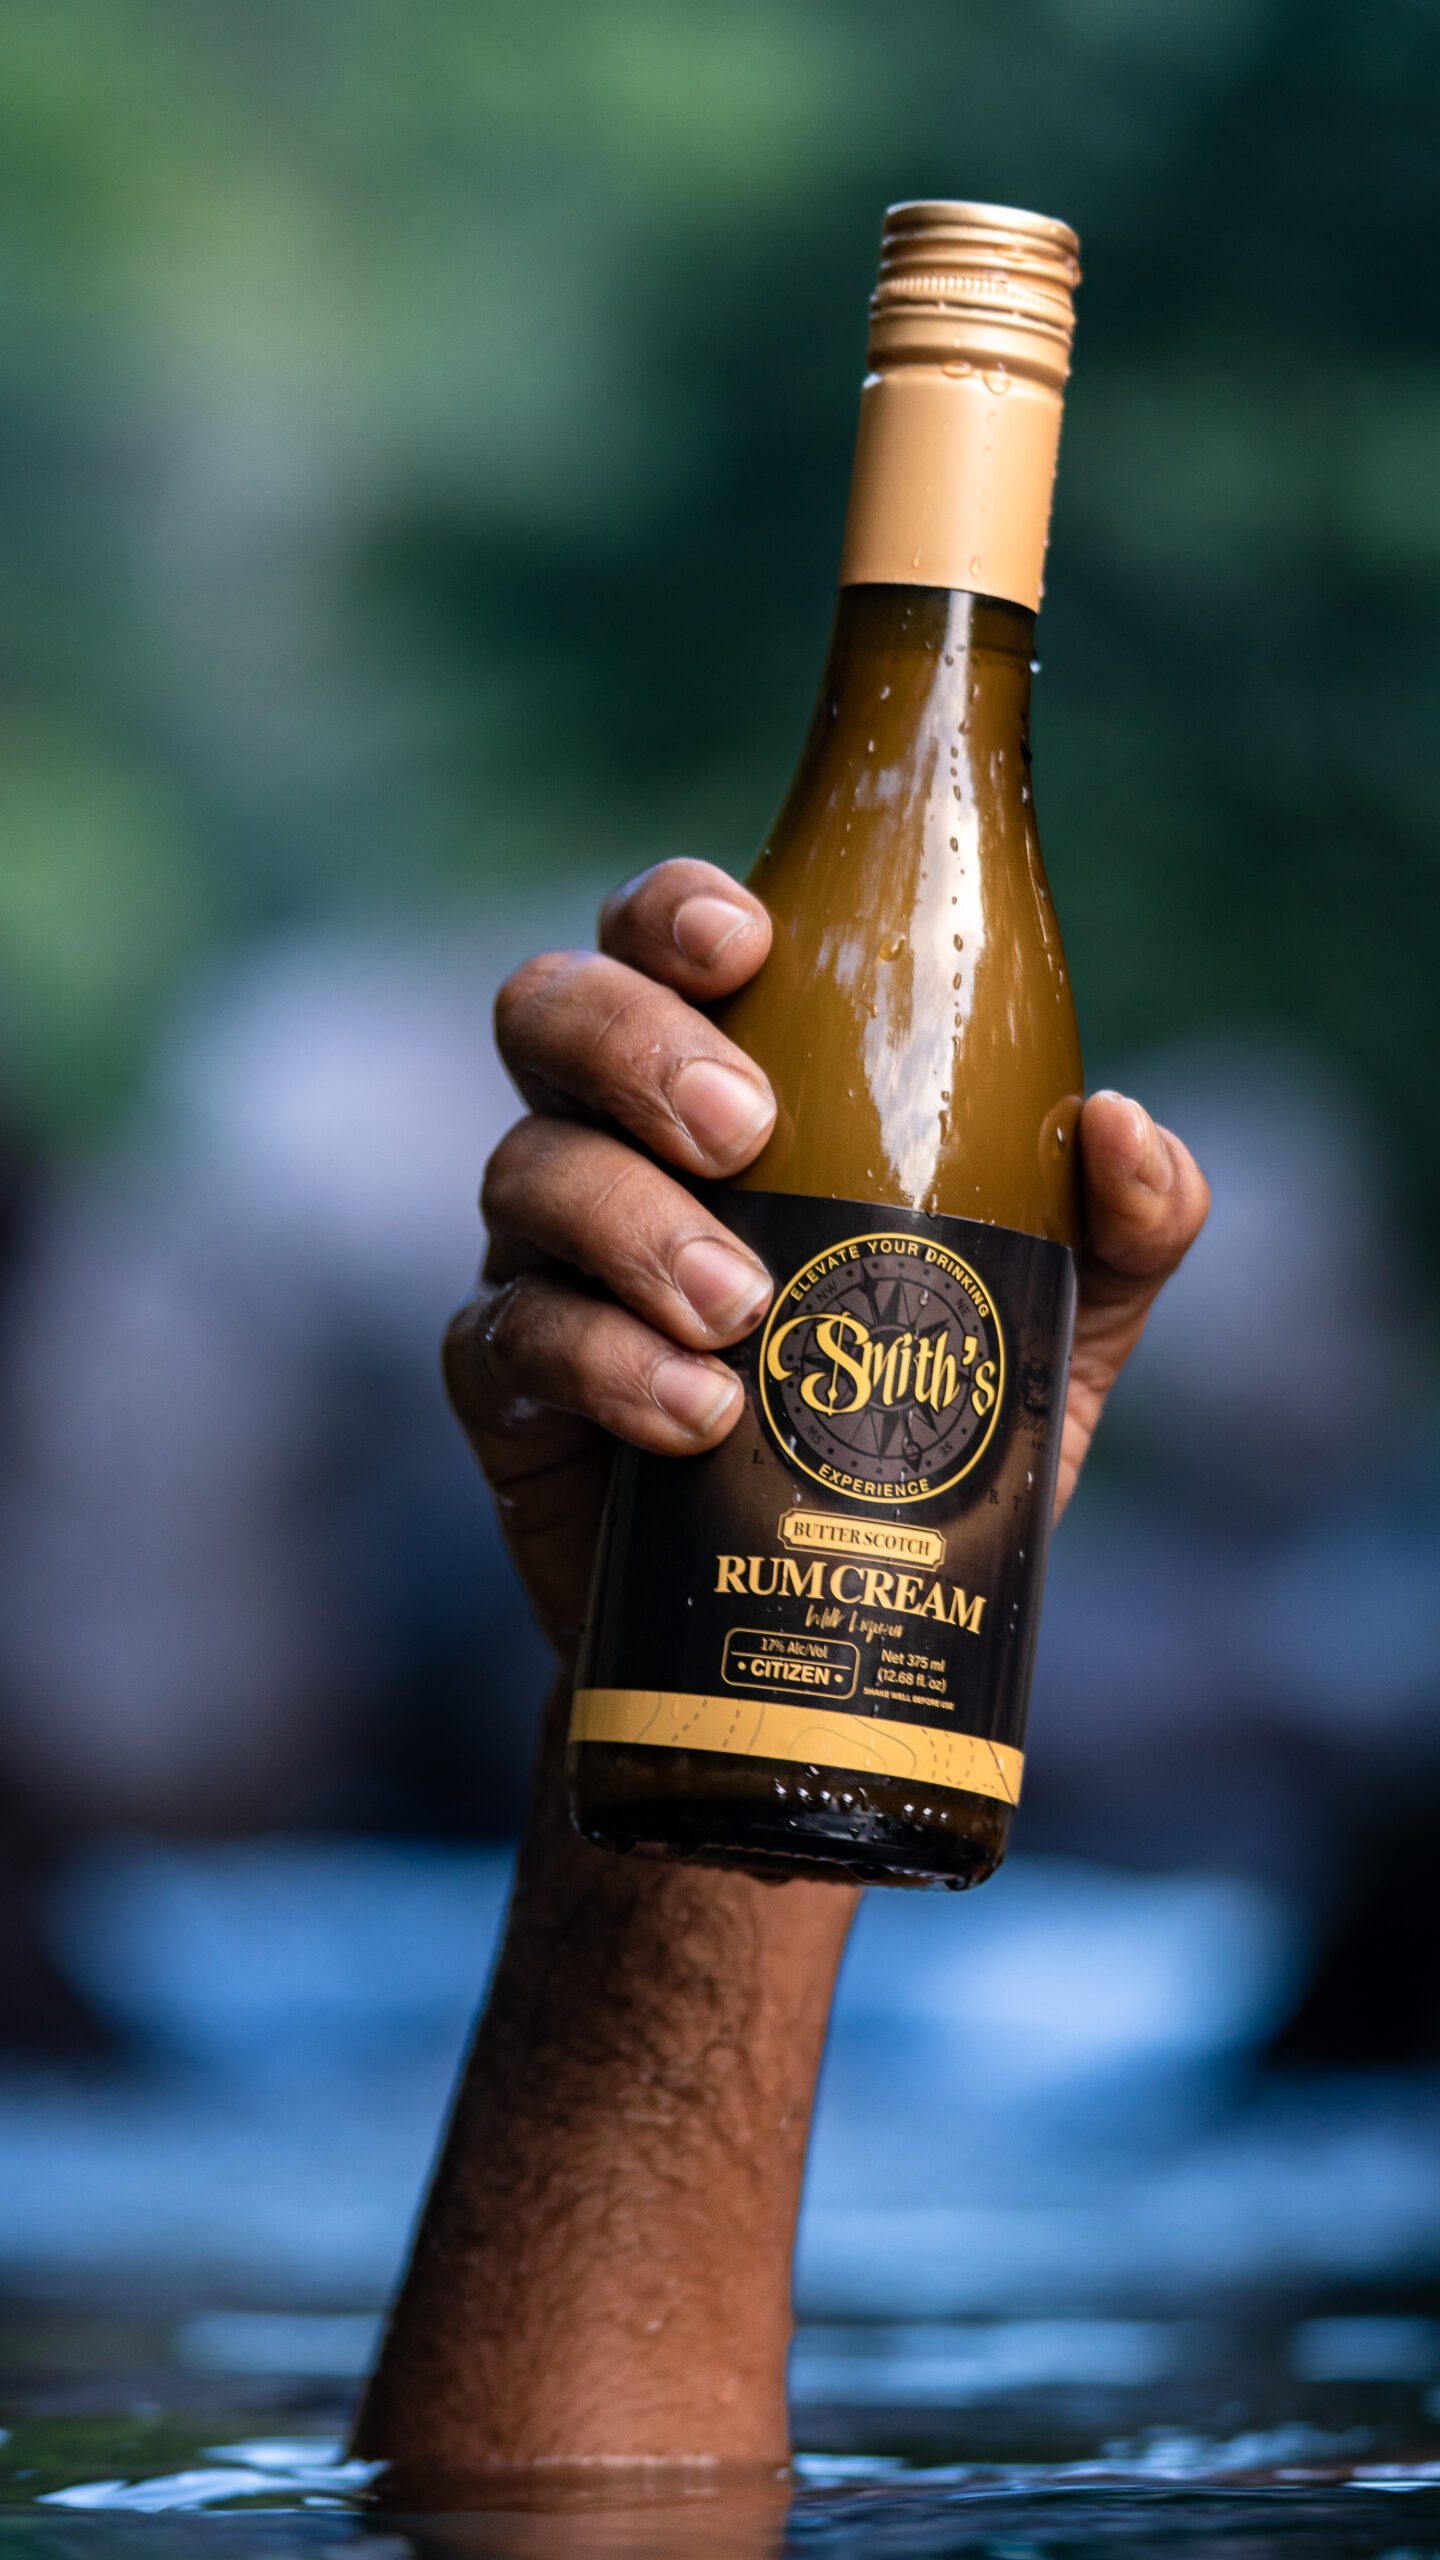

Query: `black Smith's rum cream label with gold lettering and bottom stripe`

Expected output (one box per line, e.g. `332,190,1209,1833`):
571,1190,1076,1802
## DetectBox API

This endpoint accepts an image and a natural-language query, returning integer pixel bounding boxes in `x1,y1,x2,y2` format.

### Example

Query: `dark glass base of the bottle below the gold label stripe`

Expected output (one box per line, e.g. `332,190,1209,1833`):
566,1743,1012,1892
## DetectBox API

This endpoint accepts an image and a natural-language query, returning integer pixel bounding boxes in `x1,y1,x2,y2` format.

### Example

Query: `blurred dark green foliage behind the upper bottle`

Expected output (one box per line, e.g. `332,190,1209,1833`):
0,0,1440,1208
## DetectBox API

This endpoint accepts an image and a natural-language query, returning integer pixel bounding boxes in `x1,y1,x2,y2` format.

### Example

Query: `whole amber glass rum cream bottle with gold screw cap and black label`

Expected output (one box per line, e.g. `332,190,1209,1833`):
569,205,1081,1884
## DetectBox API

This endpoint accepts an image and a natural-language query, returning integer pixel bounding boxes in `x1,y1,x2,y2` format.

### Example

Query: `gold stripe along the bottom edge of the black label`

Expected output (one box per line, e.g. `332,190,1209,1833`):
569,1690,1025,1805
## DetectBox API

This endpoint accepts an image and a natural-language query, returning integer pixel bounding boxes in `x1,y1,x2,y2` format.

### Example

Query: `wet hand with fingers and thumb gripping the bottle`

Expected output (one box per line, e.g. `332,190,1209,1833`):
446,860,1209,1661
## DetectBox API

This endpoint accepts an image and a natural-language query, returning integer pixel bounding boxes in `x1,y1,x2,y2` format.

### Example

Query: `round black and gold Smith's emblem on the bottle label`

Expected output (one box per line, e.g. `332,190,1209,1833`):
758,1231,1004,1503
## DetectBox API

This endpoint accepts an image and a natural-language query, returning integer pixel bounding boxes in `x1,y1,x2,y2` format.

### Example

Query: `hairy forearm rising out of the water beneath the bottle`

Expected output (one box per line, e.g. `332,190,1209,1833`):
356,1697,856,2470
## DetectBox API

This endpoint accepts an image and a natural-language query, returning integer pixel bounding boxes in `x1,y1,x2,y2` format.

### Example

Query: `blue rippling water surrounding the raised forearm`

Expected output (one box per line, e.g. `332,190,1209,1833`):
11,1843,1440,2560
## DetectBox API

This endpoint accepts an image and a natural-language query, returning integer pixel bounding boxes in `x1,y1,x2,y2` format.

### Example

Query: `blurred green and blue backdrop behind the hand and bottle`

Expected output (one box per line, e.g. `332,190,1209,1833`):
0,0,1440,2478
